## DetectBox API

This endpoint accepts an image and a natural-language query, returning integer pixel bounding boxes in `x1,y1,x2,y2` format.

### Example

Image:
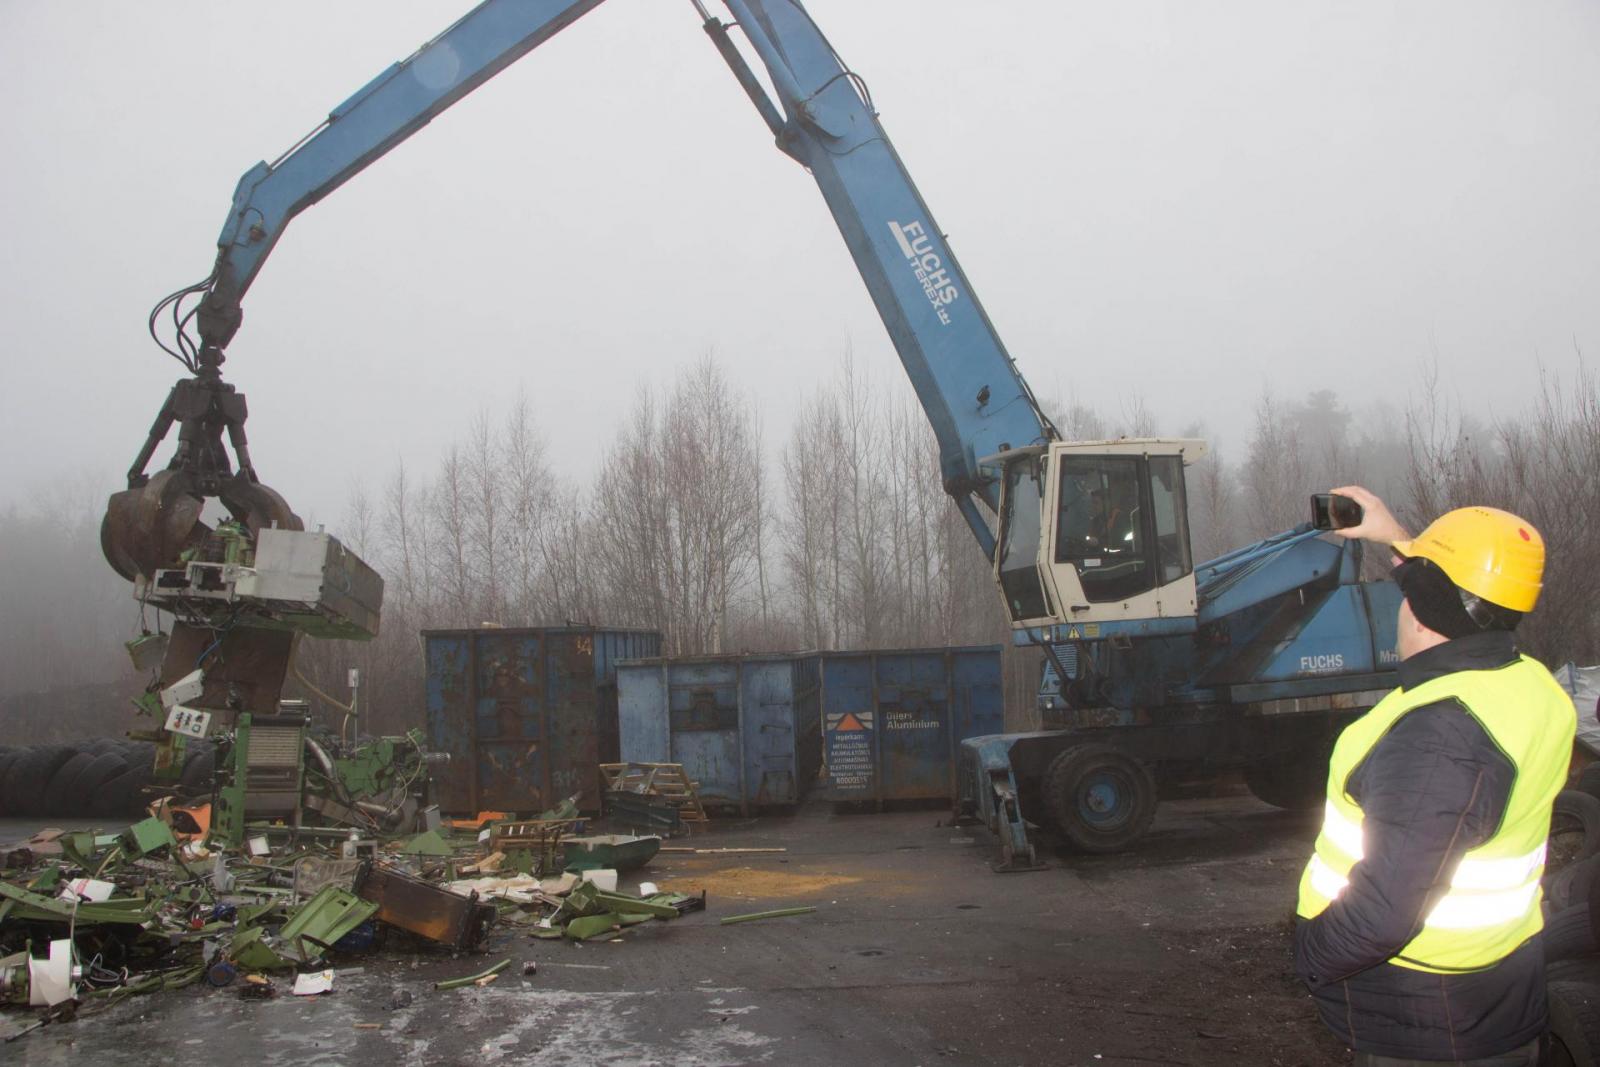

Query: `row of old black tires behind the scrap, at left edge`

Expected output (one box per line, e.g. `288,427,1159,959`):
0,737,214,819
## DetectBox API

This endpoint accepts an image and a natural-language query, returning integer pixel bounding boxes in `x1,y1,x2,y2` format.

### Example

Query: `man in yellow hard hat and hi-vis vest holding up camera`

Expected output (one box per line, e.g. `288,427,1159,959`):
1294,486,1574,1067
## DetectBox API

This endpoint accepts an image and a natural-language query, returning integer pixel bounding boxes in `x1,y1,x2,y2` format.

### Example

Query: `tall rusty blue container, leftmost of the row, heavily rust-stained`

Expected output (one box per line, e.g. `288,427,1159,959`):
422,627,661,814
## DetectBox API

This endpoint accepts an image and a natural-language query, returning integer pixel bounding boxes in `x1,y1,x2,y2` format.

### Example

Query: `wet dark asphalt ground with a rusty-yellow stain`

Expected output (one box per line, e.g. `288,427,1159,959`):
0,797,1349,1067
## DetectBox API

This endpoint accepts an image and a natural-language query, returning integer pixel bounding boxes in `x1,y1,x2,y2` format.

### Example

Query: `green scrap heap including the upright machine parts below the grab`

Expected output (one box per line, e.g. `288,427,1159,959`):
0,742,732,1032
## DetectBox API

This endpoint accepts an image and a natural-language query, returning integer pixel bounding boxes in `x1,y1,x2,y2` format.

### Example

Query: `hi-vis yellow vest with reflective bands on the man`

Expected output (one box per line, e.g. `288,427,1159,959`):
1298,656,1578,974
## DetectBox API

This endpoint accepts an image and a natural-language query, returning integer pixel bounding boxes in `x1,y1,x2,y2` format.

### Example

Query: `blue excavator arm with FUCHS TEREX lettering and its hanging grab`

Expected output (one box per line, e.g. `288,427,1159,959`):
118,0,1056,577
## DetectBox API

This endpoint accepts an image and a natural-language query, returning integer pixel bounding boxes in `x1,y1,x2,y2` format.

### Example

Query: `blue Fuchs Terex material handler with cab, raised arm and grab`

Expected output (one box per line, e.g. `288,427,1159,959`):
102,0,1398,870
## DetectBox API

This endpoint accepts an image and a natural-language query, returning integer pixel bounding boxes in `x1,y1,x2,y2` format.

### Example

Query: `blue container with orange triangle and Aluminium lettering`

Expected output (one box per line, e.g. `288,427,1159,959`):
821,645,1005,803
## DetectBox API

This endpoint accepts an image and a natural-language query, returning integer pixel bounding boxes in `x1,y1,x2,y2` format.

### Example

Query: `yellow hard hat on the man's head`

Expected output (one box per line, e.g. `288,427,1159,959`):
1394,507,1544,611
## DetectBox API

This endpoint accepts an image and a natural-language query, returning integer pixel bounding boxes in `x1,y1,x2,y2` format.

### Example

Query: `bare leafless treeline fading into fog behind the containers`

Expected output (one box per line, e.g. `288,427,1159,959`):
0,355,1600,741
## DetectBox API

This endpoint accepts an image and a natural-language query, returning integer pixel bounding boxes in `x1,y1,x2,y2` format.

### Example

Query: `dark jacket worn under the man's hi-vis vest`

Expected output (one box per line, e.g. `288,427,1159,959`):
1294,632,1547,1061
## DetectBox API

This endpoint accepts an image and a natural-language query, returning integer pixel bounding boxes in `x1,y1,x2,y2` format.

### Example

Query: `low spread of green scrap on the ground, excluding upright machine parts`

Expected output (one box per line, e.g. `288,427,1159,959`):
0,800,704,1040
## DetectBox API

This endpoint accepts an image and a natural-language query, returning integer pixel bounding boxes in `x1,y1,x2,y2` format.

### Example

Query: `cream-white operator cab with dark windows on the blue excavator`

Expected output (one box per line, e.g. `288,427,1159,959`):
984,438,1206,627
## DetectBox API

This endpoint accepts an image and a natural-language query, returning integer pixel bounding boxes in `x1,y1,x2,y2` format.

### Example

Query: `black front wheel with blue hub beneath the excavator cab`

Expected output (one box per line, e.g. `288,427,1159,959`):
1045,744,1155,853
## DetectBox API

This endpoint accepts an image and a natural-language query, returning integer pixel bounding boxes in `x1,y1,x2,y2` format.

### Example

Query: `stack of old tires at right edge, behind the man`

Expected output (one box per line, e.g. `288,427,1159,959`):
1544,783,1600,1067
